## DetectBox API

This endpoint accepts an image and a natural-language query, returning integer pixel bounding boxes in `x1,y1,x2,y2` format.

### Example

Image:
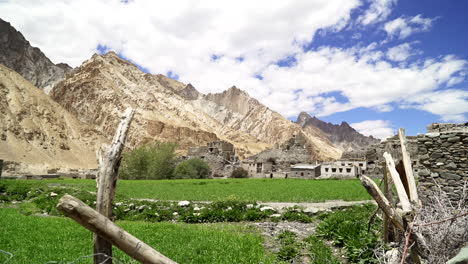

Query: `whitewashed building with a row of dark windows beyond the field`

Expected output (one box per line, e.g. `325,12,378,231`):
320,160,367,179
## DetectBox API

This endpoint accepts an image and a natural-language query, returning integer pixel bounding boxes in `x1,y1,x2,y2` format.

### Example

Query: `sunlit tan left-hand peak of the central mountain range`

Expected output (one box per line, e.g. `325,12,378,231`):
51,52,267,158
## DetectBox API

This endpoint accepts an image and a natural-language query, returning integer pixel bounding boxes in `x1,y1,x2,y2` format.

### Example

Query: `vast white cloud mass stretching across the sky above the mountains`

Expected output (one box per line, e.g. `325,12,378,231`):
0,0,467,122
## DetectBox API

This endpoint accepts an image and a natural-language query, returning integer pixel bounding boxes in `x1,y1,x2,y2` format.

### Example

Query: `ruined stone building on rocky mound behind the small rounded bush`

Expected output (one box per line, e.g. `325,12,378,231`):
187,141,239,178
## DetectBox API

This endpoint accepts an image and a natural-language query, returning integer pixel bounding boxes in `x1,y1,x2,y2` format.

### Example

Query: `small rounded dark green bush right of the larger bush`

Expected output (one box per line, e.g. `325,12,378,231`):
174,158,211,179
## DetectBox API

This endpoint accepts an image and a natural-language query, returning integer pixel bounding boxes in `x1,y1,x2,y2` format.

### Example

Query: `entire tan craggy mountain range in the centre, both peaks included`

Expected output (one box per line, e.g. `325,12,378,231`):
51,52,341,159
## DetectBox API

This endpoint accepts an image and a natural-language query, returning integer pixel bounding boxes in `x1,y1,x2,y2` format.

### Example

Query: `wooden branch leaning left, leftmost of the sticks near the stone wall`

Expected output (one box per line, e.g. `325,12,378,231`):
361,176,405,231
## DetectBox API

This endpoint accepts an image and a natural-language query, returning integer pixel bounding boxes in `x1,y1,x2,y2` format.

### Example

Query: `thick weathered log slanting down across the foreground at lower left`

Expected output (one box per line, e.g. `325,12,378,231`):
57,195,176,264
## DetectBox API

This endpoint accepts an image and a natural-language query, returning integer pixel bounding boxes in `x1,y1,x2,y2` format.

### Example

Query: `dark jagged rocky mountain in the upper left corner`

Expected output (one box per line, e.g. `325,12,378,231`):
0,19,72,93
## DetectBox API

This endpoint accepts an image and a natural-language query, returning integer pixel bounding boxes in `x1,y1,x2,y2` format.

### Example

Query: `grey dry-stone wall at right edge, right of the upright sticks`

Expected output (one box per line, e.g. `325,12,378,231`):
417,123,468,202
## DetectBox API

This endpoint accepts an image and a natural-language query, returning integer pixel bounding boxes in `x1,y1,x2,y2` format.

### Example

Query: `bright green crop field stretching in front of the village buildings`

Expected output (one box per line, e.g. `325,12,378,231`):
11,179,371,202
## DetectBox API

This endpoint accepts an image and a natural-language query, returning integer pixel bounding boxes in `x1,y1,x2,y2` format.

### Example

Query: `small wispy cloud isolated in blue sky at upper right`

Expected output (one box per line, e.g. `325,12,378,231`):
384,15,436,39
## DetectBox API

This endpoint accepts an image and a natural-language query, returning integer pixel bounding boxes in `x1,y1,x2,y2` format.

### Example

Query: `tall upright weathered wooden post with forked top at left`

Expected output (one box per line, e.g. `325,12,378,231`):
94,108,135,264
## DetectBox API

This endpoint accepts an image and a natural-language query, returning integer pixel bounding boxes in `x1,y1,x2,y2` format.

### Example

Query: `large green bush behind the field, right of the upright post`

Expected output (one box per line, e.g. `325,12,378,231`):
119,142,176,180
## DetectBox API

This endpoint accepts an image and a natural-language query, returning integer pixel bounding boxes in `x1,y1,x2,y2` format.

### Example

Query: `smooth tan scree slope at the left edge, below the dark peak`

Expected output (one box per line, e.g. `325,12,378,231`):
0,64,103,168
